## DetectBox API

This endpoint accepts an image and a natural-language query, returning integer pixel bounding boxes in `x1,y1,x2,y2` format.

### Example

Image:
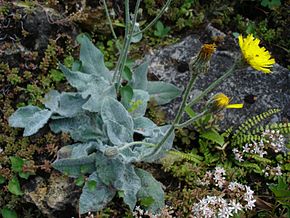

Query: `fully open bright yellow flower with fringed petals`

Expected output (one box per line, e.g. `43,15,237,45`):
239,34,275,73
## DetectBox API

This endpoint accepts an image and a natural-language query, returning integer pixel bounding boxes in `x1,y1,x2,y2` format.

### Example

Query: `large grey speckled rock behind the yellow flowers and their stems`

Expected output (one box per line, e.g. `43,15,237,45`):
149,27,290,130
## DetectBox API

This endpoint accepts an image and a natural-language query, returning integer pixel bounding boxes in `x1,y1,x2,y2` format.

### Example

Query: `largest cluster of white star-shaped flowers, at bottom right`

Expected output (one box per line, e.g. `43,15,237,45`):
192,167,256,218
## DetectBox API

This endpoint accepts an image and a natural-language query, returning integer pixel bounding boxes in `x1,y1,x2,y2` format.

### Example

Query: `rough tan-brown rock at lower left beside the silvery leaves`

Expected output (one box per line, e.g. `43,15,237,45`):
24,172,80,218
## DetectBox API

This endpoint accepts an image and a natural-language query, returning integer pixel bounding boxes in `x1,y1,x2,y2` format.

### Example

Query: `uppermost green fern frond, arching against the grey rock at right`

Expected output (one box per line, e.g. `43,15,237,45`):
233,109,281,138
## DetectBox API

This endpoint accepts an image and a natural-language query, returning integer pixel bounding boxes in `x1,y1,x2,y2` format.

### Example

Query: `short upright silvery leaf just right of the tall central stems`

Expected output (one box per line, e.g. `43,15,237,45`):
132,60,149,90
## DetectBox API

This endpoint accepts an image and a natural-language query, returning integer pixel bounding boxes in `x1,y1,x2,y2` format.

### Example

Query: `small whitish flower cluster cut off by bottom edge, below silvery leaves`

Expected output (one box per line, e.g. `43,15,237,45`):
133,205,175,218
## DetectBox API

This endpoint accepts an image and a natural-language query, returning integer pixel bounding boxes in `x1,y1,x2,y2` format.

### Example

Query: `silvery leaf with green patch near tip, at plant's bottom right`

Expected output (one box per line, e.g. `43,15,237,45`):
135,168,165,213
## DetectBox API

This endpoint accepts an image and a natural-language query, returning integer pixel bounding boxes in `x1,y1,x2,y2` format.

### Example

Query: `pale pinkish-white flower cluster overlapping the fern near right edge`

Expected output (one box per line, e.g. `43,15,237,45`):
232,130,286,162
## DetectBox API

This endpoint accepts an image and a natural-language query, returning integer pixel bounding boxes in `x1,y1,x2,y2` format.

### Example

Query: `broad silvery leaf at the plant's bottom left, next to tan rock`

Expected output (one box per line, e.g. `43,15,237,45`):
79,173,116,214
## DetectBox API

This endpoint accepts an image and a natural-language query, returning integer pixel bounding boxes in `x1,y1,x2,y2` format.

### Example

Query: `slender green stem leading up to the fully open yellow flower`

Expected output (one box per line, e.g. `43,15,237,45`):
186,60,240,107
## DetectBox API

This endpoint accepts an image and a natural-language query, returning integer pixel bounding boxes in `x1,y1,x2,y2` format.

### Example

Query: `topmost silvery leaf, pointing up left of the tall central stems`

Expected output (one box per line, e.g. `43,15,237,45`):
77,34,112,81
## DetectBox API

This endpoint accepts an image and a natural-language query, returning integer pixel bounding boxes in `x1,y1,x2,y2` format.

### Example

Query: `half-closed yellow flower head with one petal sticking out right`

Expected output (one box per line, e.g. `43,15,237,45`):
208,93,244,111
